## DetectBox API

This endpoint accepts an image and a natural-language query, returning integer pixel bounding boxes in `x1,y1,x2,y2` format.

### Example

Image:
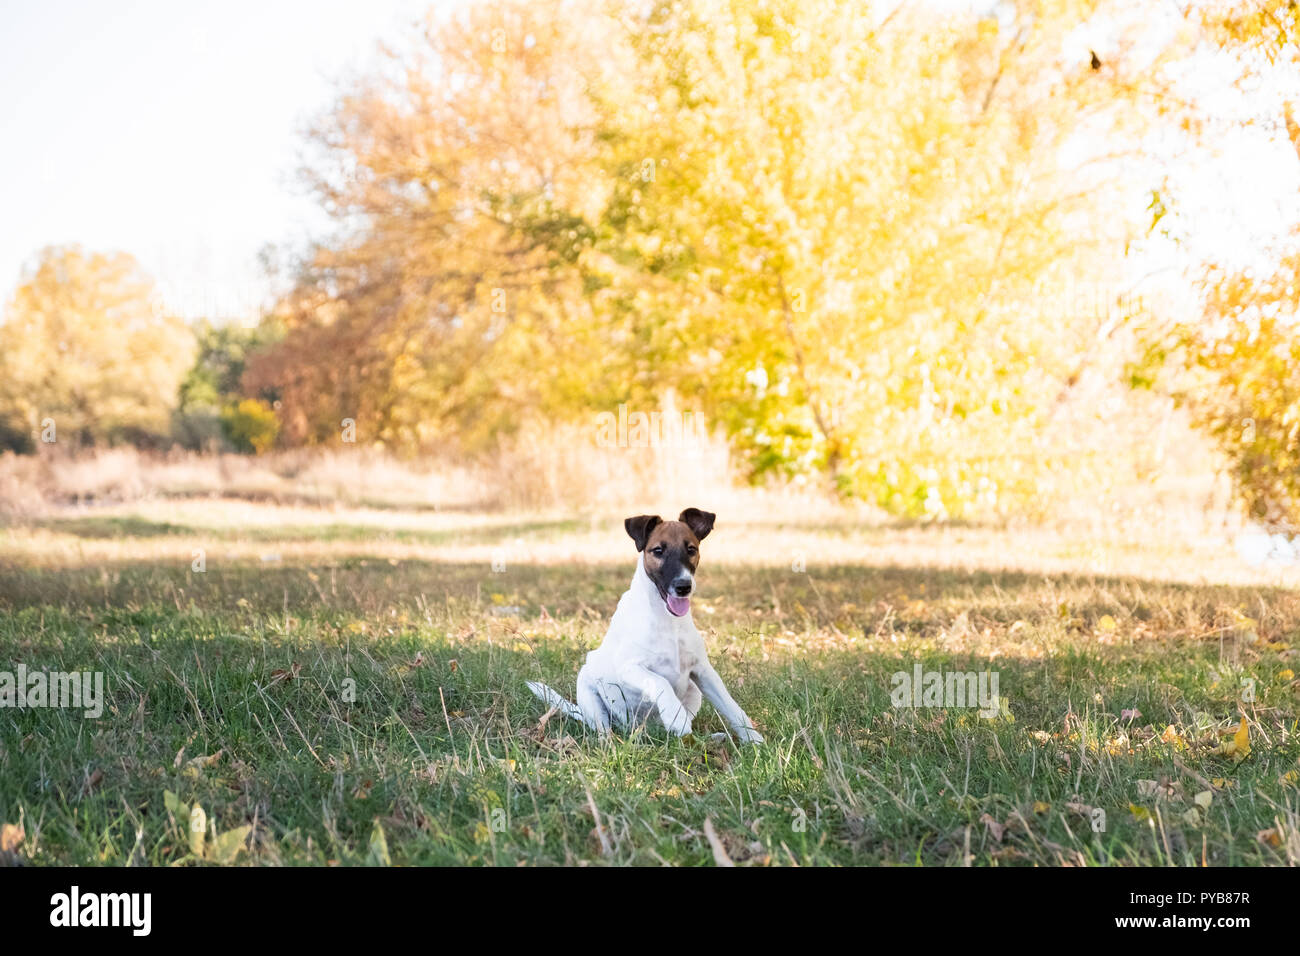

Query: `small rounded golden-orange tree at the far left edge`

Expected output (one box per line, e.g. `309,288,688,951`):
0,247,194,445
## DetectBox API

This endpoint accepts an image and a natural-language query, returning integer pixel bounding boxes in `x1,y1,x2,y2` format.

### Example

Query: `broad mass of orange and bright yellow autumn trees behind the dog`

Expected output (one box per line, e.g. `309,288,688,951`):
261,0,1182,515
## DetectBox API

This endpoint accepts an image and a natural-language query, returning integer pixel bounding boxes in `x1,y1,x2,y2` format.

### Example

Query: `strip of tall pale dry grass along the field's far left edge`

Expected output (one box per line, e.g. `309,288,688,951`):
0,427,735,516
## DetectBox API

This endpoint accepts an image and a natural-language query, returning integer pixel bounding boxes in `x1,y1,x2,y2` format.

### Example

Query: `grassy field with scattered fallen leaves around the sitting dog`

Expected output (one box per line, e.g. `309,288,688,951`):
0,501,1300,866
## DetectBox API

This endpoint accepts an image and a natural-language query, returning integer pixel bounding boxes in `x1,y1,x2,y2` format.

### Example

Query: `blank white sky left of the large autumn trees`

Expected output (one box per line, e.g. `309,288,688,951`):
0,0,441,321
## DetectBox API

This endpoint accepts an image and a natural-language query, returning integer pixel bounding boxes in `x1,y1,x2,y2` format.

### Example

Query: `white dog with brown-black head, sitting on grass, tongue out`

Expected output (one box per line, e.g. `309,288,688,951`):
528,507,763,744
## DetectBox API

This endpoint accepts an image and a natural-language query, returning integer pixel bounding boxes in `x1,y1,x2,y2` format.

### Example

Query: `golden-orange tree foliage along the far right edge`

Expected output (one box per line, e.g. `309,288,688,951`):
1140,0,1300,532
